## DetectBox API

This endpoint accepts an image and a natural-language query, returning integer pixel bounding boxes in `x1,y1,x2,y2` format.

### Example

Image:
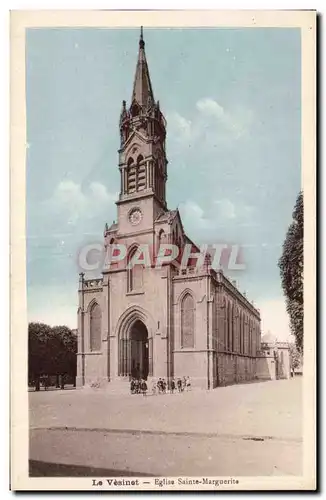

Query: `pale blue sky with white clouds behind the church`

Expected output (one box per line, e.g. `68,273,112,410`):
26,28,301,340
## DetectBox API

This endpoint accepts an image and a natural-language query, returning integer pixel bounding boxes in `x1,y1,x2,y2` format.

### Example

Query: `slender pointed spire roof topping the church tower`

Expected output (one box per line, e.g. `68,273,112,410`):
131,27,154,106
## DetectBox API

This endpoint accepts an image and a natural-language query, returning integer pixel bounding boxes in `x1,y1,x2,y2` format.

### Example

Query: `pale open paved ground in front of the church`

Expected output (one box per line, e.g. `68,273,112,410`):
29,379,302,476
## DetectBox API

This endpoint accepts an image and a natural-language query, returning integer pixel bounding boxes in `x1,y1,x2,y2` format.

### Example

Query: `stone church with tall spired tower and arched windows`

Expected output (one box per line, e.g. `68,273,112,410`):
77,31,261,389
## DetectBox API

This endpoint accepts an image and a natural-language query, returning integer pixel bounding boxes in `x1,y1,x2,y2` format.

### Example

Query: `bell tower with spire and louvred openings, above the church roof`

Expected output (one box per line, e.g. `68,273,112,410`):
117,28,168,234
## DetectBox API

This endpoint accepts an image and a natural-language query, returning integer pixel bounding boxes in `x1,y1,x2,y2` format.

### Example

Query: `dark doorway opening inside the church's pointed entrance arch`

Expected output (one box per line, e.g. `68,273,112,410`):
129,320,149,379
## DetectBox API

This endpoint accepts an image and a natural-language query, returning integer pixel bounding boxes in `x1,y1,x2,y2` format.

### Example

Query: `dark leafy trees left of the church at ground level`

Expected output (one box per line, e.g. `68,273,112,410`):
28,323,77,380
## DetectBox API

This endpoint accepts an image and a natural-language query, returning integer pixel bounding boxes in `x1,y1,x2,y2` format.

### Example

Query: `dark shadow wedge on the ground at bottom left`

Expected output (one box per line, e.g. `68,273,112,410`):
29,460,152,477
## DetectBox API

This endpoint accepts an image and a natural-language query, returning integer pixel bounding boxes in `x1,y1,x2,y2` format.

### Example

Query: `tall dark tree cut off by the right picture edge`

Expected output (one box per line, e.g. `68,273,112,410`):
278,192,304,353
